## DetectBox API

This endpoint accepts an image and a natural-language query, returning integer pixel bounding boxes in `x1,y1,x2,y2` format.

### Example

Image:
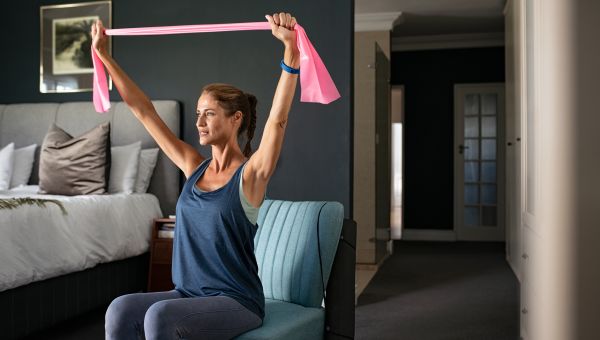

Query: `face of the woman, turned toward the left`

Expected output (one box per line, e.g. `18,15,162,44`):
196,93,241,145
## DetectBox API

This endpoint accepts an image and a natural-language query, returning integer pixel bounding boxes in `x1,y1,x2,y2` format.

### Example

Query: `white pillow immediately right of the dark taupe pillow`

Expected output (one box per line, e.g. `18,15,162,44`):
108,142,142,194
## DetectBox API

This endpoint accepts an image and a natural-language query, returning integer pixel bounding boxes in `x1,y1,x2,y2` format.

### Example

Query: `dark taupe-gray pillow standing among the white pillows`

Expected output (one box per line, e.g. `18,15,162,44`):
39,122,110,196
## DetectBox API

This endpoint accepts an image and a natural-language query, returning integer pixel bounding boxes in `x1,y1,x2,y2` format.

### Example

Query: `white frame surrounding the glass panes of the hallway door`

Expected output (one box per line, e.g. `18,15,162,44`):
452,83,506,241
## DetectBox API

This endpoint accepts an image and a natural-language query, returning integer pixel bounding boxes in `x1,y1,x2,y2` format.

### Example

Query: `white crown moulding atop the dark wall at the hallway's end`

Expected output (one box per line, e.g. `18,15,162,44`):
392,32,504,52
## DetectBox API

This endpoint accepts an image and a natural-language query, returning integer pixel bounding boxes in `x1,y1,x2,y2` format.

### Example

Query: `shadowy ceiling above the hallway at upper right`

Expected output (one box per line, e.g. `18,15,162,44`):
354,0,506,37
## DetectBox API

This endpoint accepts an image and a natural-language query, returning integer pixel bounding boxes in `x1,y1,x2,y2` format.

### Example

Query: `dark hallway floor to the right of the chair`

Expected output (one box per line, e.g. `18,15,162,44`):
356,241,519,340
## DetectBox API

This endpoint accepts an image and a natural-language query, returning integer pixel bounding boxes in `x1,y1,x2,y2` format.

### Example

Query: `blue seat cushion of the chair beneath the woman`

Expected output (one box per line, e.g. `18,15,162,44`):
236,299,325,340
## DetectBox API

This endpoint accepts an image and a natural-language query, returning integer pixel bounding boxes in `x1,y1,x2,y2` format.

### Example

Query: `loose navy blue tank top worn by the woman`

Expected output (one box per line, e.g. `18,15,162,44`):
172,158,265,319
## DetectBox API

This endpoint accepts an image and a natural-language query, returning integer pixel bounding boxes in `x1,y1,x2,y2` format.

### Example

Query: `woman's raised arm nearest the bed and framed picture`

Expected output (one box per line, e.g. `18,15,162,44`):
92,20,204,177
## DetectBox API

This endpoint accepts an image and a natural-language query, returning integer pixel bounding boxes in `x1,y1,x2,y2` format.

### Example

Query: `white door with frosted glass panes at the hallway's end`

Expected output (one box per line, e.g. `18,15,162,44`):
454,84,505,241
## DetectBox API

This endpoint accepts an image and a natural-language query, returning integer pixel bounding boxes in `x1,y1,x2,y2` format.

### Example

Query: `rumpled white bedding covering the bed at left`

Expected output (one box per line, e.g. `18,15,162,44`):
0,186,162,291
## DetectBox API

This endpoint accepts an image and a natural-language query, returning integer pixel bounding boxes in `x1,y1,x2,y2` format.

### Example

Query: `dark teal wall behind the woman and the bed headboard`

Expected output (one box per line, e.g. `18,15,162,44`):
0,0,354,217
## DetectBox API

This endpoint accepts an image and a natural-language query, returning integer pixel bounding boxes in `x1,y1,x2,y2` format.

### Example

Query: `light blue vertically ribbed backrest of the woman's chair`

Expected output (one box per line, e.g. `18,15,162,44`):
254,200,344,307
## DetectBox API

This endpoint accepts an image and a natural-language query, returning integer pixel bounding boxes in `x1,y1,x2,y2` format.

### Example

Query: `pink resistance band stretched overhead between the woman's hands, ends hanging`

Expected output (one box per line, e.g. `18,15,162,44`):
92,22,340,112
